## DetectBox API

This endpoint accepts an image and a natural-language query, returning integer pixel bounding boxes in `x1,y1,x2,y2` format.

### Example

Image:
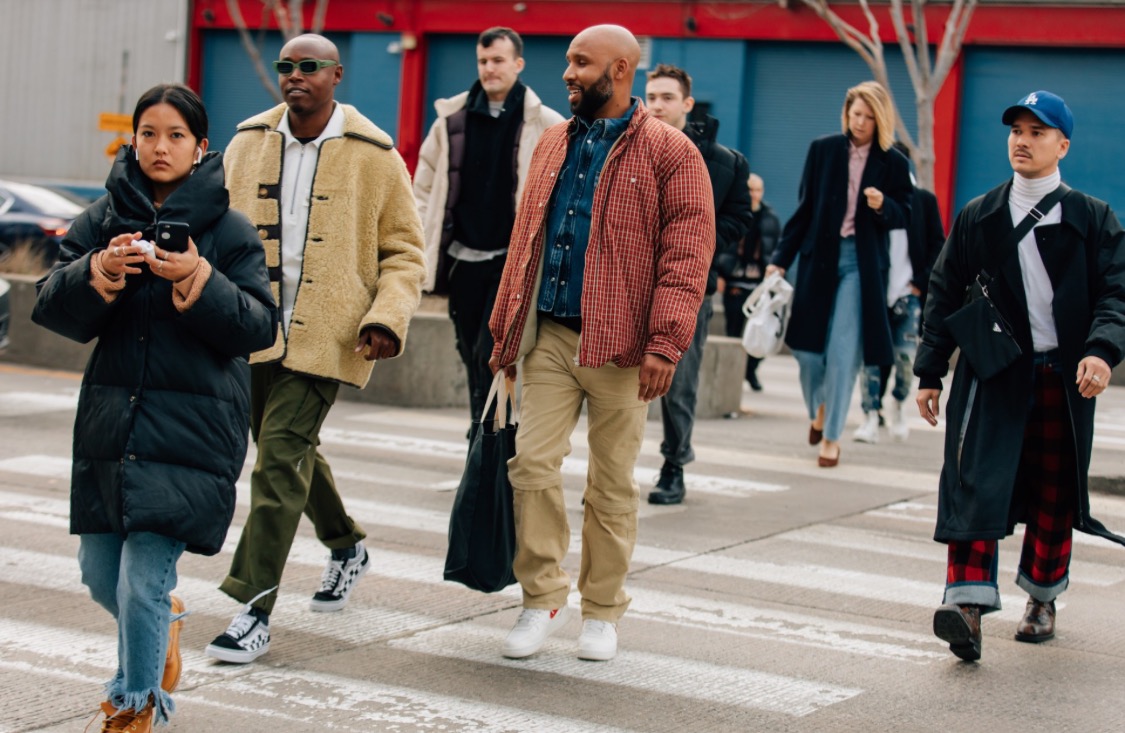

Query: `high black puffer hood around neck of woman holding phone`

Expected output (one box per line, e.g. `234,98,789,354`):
104,145,231,241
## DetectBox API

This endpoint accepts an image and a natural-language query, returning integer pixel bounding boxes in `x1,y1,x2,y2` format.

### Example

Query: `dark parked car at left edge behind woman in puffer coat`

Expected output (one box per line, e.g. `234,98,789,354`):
0,180,86,264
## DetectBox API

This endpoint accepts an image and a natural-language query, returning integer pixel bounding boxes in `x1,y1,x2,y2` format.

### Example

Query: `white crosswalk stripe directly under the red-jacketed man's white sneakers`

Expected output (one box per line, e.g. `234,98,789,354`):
389,624,863,717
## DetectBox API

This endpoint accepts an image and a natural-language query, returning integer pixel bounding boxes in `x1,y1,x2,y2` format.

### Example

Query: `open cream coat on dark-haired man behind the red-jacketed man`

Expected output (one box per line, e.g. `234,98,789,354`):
414,87,564,291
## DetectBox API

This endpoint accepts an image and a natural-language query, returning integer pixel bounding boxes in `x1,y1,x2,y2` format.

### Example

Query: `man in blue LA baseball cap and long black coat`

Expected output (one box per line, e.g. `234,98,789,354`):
915,91,1125,661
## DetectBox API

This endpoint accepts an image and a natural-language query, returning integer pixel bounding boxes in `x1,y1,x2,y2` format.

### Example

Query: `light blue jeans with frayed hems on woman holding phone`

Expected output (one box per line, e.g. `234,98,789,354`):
78,532,185,724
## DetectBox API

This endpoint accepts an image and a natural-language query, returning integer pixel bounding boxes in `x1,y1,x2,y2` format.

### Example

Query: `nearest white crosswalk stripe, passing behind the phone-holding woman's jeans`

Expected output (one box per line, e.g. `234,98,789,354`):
0,621,634,733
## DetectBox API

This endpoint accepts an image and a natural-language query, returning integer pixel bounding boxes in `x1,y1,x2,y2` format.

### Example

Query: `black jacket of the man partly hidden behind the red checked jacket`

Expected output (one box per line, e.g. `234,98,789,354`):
684,116,753,295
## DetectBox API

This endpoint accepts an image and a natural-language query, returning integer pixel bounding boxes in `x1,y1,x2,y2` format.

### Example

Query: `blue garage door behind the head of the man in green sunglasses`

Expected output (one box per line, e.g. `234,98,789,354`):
203,30,402,150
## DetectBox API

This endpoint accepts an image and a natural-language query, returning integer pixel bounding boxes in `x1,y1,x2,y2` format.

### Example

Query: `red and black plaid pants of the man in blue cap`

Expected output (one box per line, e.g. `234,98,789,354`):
946,363,1078,600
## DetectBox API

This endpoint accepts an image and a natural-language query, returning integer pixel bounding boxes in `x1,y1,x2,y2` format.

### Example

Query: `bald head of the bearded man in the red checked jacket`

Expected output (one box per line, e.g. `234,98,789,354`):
563,25,640,118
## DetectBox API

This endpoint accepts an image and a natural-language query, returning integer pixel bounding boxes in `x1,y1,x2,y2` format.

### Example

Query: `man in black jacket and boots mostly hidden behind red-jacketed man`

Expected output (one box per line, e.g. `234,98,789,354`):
645,64,752,504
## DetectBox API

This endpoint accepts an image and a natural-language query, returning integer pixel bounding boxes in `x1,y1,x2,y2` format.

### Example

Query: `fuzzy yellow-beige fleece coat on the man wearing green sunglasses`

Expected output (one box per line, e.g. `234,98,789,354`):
224,105,425,387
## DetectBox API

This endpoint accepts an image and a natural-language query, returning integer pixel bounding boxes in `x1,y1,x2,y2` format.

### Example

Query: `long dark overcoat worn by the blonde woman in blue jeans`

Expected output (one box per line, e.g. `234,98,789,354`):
772,135,914,364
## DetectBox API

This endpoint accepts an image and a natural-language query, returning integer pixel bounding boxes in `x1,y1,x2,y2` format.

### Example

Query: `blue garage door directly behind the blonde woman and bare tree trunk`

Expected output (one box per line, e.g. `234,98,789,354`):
741,43,917,224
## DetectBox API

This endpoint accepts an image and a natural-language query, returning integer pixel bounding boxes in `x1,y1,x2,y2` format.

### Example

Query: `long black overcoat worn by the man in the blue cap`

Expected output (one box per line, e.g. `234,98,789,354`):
915,181,1125,544
